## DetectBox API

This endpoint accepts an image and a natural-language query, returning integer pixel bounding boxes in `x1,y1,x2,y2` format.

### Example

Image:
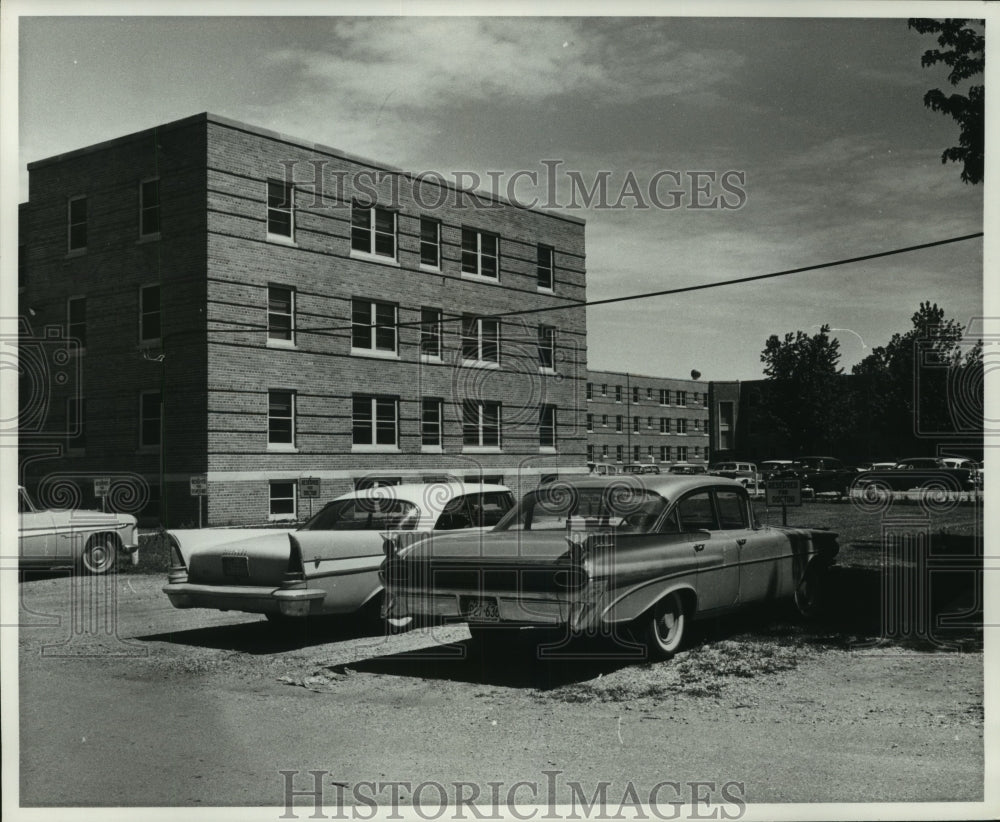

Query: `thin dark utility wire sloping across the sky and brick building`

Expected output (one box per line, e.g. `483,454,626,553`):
203,231,984,337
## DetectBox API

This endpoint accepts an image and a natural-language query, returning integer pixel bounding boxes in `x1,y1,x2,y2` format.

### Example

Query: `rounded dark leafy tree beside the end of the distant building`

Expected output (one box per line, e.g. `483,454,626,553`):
760,325,847,454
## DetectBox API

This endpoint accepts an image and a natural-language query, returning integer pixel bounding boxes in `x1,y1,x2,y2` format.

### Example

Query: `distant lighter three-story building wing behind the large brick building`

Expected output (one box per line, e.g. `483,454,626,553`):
584,371,709,465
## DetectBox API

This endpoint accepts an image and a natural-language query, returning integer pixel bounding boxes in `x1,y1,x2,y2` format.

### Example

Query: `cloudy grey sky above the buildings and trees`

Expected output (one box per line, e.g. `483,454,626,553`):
11,3,983,380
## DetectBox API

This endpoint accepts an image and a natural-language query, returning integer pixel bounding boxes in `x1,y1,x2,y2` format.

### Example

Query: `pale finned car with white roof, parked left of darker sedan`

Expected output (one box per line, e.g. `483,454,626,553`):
163,482,514,620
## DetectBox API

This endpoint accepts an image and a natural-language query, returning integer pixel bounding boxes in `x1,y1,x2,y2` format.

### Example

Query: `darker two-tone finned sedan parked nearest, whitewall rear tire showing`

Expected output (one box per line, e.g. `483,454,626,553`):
382,474,838,658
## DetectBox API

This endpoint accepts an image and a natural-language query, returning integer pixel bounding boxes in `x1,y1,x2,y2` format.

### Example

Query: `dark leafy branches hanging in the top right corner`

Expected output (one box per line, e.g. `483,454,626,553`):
908,18,986,185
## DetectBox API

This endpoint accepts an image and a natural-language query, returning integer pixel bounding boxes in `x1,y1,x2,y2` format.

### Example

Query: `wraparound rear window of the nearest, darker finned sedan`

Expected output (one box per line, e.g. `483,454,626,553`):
496,485,667,534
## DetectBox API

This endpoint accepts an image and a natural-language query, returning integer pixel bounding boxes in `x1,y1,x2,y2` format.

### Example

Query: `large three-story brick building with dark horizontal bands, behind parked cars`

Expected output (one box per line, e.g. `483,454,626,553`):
19,114,584,527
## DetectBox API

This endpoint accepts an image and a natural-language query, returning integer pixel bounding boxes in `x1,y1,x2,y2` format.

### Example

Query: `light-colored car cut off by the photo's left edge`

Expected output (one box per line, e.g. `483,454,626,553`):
17,486,139,574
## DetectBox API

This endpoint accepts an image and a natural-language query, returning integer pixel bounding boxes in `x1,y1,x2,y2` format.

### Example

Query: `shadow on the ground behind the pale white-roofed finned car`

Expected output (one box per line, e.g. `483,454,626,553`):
136,615,402,655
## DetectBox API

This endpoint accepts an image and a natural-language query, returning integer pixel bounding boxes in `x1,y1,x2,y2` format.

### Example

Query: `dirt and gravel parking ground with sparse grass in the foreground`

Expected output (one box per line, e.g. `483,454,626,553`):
18,574,984,818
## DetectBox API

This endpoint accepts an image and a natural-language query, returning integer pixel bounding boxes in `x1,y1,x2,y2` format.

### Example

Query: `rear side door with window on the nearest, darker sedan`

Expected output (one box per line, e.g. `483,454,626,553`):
676,488,740,611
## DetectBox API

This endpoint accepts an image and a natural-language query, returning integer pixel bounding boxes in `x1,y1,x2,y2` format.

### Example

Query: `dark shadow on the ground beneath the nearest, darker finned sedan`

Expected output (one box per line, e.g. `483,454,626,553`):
328,630,646,691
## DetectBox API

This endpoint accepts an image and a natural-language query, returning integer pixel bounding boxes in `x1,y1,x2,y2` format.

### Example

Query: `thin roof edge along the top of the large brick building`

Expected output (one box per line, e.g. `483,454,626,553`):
28,111,587,225
